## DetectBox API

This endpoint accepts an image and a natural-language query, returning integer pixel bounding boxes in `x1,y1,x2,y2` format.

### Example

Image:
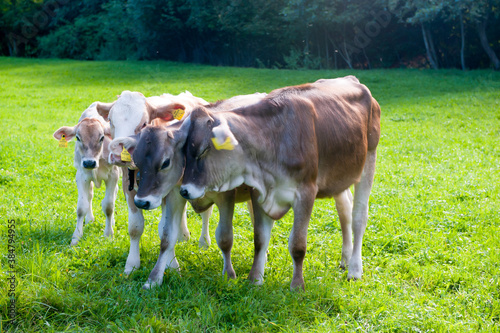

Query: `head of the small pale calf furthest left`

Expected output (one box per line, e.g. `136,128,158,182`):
54,118,111,169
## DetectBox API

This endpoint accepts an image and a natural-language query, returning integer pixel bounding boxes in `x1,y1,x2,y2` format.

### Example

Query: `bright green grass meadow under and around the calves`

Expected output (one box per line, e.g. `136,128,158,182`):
0,58,500,332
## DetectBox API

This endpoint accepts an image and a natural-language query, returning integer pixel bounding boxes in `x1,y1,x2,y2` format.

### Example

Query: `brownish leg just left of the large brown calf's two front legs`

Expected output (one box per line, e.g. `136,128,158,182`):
215,191,236,279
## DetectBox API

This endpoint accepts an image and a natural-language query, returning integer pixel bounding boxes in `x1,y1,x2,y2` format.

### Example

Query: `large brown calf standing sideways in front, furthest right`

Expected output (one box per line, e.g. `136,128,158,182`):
179,76,380,289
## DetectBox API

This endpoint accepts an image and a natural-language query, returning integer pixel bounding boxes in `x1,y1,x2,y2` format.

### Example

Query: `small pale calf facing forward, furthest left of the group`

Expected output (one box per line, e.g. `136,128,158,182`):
54,103,120,245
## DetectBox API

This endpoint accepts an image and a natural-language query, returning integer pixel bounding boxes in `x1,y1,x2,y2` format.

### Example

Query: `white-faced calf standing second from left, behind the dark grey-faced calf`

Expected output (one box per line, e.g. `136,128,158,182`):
97,91,210,275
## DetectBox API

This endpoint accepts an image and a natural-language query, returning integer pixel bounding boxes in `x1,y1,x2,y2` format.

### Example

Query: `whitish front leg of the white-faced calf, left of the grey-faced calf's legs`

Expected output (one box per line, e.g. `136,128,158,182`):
122,180,144,275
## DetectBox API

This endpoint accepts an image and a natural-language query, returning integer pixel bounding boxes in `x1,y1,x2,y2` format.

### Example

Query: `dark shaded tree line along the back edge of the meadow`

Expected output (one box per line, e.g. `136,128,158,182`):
0,0,500,70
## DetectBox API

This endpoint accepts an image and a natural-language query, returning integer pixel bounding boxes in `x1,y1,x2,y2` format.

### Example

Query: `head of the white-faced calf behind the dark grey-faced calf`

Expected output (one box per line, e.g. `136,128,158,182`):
96,90,190,168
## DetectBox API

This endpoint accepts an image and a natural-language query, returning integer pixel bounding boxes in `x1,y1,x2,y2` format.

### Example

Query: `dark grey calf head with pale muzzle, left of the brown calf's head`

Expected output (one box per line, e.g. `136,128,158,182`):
113,125,185,209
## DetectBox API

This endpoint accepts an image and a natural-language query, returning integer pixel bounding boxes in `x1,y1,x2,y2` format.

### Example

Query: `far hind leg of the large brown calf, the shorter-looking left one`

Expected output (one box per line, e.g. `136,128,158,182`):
334,189,352,269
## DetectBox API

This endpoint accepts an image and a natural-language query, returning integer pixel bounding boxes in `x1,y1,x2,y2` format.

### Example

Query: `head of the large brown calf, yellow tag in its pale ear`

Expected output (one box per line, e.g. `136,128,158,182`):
180,107,245,200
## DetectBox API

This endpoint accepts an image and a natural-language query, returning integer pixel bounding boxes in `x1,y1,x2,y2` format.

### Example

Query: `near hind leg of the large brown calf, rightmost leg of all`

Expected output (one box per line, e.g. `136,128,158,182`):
347,151,377,280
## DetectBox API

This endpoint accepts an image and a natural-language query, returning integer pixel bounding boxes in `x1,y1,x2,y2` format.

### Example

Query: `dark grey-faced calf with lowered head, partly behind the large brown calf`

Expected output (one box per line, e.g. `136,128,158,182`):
111,94,266,288
